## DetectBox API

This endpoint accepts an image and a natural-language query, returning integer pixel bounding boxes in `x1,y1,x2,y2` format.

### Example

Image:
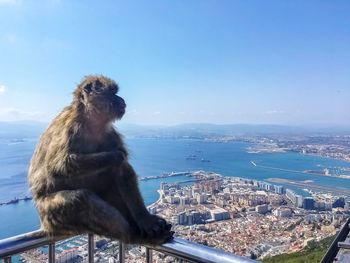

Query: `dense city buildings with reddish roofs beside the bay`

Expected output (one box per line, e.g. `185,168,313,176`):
149,171,350,259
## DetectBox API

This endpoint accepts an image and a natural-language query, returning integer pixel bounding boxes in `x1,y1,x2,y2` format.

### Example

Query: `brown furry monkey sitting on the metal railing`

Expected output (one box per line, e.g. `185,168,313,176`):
28,75,174,245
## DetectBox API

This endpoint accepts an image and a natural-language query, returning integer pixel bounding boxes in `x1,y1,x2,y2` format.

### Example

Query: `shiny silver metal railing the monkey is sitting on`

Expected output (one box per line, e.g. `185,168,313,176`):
0,230,257,263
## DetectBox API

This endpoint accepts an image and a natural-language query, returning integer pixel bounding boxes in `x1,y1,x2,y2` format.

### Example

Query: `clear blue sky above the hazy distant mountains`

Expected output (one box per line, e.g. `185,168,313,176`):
0,0,350,126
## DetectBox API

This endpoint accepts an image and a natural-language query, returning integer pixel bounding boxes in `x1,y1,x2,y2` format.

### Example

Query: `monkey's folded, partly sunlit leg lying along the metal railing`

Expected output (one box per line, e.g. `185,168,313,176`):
38,190,133,243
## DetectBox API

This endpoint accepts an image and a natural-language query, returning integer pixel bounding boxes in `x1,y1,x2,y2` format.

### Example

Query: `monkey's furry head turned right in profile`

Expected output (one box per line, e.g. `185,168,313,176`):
74,75,126,122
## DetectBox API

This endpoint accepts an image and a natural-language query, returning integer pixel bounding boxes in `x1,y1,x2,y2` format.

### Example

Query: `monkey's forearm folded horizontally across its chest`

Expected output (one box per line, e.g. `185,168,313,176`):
68,151,125,173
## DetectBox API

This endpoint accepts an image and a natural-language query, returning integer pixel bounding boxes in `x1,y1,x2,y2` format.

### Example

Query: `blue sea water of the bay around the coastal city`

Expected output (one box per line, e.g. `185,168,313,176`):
0,138,350,239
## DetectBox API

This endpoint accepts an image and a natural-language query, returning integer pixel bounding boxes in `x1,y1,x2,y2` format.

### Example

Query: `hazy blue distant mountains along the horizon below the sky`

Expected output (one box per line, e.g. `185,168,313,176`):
0,121,350,138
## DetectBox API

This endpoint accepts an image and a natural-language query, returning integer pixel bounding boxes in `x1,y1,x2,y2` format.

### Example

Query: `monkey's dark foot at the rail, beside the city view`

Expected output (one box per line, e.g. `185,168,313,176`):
137,215,174,245
